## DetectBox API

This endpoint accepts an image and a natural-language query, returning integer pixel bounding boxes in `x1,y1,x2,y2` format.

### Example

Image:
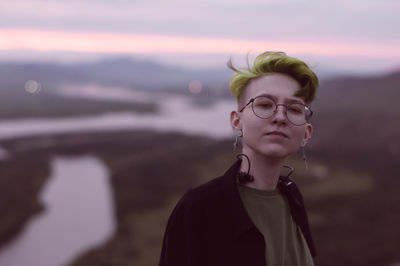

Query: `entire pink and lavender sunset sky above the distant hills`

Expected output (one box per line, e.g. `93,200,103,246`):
0,0,400,73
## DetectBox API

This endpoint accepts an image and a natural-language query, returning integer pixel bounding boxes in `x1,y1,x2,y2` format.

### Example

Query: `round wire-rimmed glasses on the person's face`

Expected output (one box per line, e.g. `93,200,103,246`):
239,96,313,126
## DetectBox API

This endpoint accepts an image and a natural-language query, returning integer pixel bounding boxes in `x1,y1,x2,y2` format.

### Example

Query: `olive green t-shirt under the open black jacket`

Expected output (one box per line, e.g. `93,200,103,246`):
238,184,314,266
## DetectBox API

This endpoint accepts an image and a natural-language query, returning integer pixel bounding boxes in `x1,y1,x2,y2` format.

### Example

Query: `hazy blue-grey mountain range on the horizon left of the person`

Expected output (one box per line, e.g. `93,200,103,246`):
0,58,230,91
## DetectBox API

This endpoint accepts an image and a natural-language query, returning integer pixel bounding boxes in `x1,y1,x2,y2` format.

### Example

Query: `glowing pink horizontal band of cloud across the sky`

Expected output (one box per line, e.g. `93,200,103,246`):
0,28,400,58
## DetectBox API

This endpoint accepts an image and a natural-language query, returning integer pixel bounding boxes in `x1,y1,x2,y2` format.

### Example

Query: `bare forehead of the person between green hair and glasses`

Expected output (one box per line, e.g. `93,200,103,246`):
242,73,304,103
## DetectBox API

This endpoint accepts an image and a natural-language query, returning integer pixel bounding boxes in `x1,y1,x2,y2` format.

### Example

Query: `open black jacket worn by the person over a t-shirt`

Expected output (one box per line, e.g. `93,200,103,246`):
159,160,316,266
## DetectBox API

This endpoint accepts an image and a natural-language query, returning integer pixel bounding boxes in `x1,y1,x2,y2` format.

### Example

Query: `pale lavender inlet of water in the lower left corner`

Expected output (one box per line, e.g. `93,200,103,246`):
0,156,115,266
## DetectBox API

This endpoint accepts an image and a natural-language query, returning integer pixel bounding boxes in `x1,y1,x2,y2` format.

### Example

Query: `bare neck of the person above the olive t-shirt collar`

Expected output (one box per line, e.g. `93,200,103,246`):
240,150,285,190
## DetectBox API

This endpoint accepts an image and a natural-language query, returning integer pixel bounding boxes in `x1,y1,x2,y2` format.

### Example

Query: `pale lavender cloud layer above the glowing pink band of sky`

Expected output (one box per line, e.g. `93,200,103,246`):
0,0,400,41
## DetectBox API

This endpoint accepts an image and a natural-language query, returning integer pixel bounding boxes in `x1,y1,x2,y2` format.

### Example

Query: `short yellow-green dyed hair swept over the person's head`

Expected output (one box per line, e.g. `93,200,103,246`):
228,51,318,103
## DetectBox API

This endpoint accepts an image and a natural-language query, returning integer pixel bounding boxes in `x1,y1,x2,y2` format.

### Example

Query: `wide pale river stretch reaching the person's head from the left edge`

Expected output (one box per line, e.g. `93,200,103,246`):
0,93,236,140
